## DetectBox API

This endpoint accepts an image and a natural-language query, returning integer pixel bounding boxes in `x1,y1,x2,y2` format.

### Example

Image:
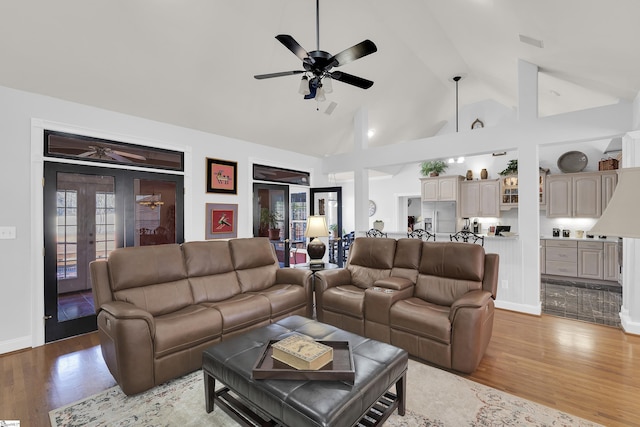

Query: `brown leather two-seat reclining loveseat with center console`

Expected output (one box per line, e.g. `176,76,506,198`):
315,237,499,373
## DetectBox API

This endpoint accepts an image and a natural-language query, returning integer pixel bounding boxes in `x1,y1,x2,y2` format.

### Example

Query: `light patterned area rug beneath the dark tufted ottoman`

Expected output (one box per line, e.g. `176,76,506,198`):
49,360,599,427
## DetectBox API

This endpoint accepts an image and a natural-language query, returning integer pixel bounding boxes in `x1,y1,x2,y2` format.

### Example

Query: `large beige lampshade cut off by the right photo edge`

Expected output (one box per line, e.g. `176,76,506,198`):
589,167,640,239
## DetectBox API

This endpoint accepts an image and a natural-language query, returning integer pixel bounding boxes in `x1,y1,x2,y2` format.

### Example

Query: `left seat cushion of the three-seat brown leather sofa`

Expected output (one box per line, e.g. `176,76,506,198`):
154,305,222,358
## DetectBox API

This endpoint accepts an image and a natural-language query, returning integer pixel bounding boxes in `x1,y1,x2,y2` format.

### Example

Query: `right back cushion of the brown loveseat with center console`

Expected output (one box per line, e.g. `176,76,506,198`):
415,242,484,306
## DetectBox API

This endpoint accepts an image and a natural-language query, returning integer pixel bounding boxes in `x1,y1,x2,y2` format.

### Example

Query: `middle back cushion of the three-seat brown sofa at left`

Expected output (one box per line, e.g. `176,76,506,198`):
182,240,241,303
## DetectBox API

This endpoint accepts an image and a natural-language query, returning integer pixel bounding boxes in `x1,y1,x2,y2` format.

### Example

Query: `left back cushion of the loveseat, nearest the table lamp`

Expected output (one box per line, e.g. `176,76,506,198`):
347,237,396,289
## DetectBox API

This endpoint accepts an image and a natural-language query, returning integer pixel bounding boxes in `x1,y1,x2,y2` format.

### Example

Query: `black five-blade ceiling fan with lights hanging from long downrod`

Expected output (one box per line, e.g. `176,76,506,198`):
254,0,378,101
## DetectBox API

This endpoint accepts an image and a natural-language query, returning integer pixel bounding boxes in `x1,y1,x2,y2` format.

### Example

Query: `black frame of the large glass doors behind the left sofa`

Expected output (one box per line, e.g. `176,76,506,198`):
43,161,184,342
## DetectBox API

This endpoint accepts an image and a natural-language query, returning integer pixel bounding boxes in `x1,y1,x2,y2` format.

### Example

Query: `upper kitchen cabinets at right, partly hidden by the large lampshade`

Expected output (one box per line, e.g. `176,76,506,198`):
547,171,617,218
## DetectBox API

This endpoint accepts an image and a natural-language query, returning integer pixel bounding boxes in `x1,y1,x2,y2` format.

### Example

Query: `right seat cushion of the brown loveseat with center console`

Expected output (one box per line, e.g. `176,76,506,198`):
389,297,451,344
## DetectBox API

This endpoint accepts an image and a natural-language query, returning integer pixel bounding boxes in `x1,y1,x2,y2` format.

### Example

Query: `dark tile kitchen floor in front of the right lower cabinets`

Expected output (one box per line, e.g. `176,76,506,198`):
540,276,622,328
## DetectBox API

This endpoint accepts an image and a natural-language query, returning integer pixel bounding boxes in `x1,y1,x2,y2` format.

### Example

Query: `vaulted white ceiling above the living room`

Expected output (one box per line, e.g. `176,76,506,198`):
0,0,640,156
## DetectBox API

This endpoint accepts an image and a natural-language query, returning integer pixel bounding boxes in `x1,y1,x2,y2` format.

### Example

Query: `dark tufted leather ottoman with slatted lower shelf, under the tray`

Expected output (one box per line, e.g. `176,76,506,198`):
202,316,408,427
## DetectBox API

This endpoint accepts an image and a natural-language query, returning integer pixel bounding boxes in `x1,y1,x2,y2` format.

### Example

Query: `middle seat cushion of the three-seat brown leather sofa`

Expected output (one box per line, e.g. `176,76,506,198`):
203,293,271,338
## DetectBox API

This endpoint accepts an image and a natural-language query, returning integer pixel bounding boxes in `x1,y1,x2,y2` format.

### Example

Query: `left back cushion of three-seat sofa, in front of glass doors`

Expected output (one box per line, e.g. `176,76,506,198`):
107,244,193,316
